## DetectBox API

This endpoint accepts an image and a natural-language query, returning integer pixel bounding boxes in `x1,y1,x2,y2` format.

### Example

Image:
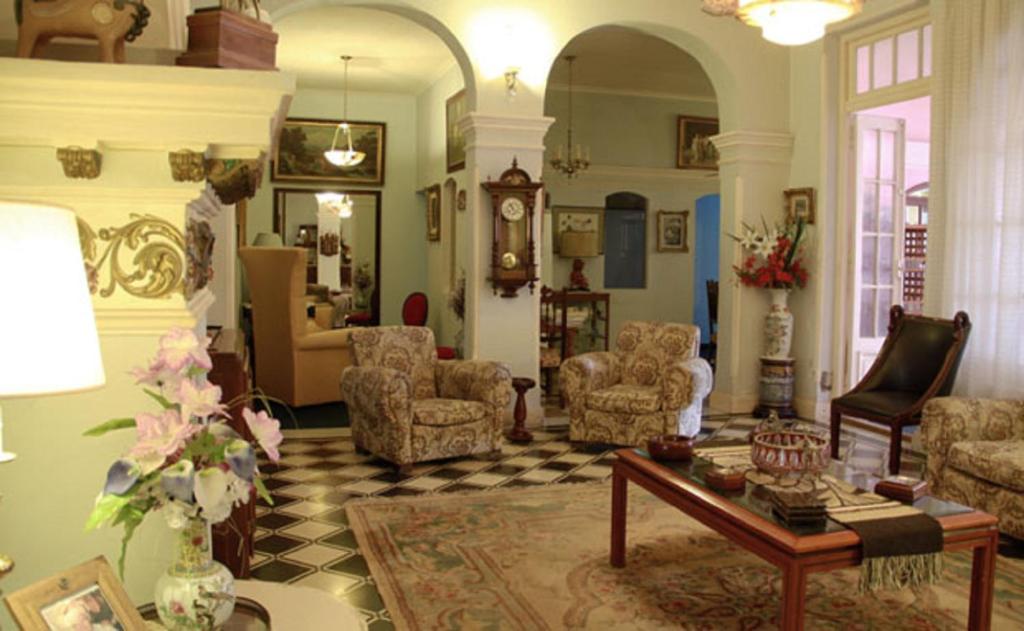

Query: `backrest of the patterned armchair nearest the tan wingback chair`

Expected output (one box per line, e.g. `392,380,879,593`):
349,327,437,399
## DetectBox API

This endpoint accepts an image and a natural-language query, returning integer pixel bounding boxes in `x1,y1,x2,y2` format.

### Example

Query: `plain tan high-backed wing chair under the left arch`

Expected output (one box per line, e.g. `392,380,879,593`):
239,248,352,407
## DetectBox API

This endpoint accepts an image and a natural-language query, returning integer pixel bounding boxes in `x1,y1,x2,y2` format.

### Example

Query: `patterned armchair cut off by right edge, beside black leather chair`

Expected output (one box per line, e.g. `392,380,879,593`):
921,396,1024,539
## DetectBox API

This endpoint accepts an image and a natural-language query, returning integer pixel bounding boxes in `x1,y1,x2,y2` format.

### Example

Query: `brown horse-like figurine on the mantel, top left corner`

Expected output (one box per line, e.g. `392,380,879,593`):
14,0,150,64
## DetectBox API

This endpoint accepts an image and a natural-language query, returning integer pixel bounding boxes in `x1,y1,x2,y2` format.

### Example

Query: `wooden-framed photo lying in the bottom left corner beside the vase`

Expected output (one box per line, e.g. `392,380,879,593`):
4,556,146,631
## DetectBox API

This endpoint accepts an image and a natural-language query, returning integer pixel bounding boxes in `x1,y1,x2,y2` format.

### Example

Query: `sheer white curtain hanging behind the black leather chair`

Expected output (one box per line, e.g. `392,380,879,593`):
928,0,1024,398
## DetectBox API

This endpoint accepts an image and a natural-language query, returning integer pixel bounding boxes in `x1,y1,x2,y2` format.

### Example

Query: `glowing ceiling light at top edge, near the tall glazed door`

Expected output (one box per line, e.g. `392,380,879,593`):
702,0,863,46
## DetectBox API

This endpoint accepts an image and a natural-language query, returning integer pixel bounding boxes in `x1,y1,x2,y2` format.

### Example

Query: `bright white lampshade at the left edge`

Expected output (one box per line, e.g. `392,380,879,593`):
0,201,105,397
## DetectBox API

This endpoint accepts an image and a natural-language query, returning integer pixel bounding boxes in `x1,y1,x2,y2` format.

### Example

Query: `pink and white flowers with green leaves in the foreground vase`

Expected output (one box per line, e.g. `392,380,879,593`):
85,328,282,577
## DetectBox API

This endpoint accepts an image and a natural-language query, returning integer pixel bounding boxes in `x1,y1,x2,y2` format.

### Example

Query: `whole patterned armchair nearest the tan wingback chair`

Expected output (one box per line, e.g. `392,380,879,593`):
341,327,512,469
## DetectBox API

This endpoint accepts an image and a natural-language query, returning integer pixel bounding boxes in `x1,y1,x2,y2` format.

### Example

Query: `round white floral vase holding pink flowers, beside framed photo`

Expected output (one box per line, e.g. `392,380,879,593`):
154,517,234,631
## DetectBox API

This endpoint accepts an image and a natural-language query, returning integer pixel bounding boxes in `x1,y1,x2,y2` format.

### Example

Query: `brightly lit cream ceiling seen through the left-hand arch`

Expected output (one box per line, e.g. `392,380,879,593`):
273,6,455,94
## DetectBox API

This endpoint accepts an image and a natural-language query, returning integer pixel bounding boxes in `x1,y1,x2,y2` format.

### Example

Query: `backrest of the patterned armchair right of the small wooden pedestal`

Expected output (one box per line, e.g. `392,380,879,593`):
615,321,700,386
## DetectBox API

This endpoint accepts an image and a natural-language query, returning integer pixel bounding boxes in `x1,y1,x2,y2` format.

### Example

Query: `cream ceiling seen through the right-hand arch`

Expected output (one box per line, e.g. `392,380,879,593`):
549,27,715,99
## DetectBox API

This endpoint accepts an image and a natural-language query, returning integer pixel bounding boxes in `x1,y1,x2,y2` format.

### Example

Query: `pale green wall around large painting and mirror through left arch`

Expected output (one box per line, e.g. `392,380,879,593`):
246,88,427,324
